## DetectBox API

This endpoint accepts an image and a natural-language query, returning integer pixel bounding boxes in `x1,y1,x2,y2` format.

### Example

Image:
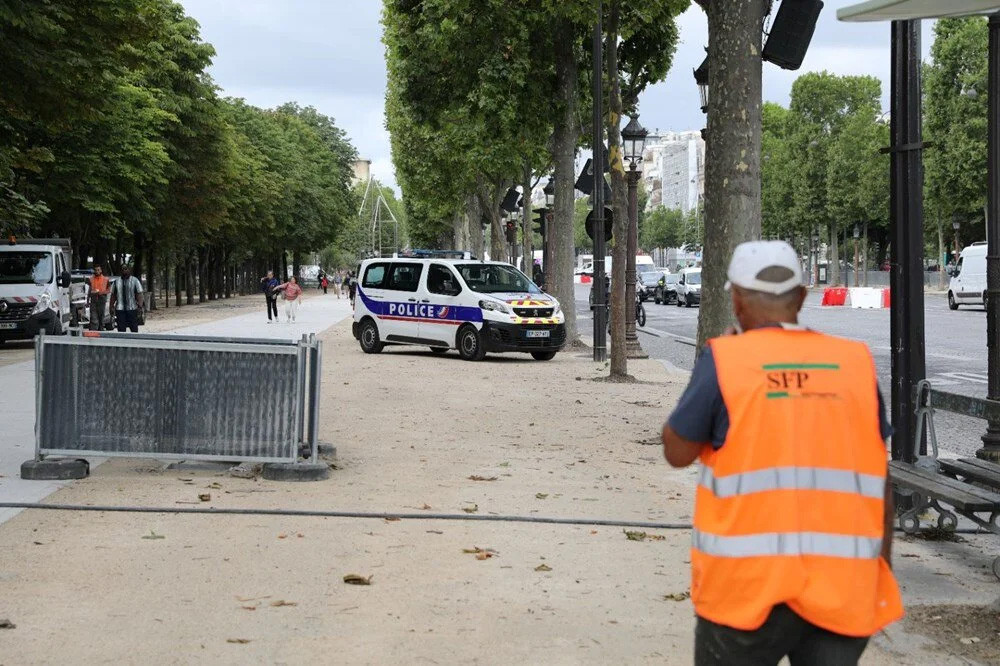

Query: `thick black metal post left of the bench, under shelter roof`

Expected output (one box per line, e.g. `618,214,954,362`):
889,21,926,462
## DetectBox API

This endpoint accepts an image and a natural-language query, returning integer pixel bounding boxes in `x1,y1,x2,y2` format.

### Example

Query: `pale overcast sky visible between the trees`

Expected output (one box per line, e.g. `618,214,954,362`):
181,0,931,192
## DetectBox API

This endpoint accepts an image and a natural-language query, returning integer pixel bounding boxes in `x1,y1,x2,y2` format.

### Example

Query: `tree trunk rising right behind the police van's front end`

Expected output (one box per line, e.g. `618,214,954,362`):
546,20,580,344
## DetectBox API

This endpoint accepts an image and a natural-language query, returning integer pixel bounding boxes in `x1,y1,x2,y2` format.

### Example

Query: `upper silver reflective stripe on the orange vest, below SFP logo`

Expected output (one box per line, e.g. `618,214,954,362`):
698,465,885,499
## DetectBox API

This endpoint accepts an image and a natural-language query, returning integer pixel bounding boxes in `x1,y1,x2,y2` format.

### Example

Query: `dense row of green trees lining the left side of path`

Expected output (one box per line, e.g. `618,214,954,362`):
0,0,357,304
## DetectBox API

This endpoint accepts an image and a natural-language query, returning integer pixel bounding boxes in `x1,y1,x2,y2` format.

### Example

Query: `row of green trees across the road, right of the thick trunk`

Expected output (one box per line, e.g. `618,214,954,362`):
762,18,989,281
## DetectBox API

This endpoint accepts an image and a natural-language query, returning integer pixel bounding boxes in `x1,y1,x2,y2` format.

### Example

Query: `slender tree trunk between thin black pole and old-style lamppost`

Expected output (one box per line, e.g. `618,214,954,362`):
604,0,634,379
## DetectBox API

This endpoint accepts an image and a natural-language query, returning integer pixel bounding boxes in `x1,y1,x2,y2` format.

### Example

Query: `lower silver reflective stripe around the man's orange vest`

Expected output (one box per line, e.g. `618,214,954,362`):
691,530,882,560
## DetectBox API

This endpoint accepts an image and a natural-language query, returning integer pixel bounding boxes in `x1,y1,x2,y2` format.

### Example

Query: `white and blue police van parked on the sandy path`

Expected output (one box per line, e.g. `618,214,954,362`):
353,253,566,361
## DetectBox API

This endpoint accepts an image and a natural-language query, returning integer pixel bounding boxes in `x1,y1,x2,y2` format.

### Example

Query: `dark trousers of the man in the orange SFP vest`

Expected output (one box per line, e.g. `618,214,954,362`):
694,604,868,666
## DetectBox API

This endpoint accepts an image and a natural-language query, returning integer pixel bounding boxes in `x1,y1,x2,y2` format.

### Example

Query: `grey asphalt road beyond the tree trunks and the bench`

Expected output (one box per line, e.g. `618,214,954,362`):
576,285,986,455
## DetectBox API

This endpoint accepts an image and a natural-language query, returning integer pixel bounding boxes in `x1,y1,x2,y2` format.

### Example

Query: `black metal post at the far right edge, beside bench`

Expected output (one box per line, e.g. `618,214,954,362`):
976,14,1000,462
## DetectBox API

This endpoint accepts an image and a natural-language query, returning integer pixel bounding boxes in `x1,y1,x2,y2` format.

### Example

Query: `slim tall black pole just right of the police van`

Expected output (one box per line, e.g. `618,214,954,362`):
592,0,608,363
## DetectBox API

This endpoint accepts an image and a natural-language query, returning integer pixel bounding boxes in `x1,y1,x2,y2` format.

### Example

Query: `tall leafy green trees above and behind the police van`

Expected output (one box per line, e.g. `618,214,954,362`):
383,0,689,374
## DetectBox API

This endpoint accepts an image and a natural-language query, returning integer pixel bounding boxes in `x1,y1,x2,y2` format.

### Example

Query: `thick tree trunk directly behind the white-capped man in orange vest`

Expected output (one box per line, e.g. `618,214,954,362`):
698,0,771,349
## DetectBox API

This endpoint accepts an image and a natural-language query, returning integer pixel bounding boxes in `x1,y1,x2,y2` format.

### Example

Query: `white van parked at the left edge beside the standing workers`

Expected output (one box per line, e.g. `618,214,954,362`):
0,238,86,342
